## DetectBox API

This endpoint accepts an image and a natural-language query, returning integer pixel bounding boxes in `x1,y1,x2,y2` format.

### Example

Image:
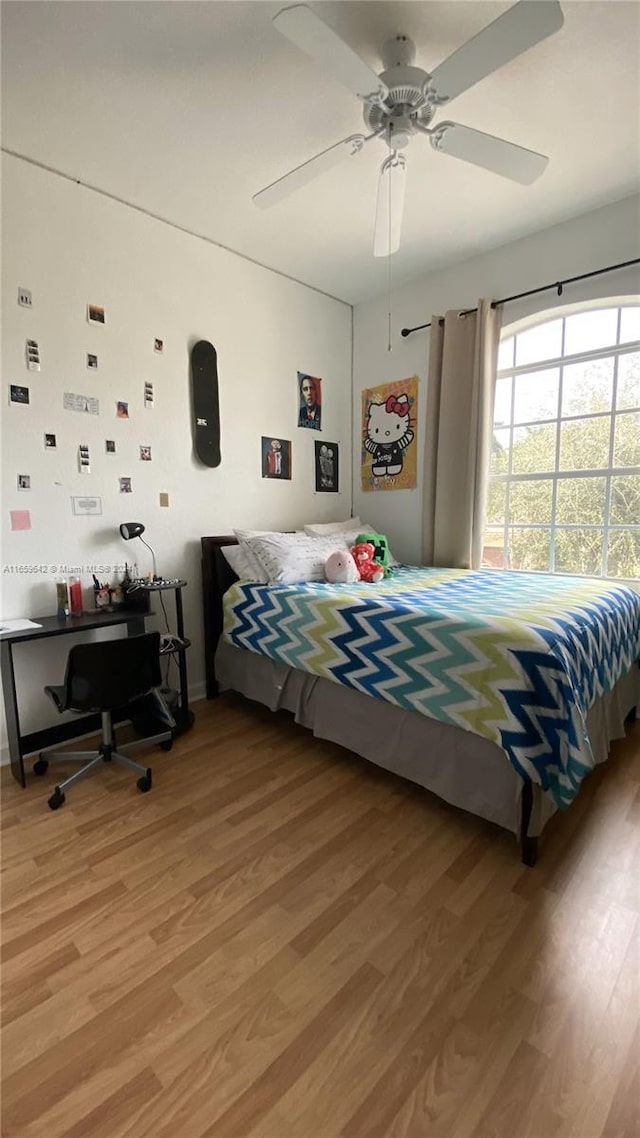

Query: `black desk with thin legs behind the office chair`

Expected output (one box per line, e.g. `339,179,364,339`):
0,610,146,786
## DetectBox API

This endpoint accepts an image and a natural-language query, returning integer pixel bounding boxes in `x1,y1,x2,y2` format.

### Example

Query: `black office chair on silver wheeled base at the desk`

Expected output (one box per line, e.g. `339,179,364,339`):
33,633,175,810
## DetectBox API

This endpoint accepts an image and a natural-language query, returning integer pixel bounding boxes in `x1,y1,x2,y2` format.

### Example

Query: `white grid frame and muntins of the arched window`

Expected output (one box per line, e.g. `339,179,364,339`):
483,296,640,587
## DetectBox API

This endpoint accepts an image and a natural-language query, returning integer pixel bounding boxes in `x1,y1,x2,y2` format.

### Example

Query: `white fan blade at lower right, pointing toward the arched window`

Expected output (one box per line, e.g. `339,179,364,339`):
430,123,549,185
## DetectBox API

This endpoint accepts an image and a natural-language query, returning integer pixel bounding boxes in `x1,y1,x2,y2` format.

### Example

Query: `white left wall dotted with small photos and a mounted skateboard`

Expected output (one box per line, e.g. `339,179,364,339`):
0,151,352,729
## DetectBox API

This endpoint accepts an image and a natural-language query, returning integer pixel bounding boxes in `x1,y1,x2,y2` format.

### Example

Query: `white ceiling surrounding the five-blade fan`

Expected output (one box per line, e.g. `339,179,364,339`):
2,0,640,303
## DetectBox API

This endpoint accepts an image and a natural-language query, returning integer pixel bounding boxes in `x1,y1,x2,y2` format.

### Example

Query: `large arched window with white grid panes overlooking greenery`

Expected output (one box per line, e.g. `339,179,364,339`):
483,303,640,580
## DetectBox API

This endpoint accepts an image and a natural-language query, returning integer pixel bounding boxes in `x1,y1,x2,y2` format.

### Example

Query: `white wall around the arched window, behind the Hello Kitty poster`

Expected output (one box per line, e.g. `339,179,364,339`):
353,197,640,563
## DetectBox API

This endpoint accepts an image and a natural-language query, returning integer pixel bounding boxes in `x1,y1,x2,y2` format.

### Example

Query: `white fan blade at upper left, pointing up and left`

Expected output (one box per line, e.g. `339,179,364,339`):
273,3,388,102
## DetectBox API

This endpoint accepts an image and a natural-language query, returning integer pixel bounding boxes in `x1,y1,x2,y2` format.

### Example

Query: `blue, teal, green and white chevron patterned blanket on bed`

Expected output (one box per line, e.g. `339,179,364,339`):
223,567,640,807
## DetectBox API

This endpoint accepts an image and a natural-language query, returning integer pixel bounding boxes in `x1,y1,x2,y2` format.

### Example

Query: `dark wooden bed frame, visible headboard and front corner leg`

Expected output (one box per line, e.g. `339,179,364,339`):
200,535,538,866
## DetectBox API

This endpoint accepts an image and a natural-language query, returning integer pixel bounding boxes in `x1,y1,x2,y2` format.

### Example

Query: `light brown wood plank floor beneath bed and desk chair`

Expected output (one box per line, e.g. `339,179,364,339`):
2,696,640,1138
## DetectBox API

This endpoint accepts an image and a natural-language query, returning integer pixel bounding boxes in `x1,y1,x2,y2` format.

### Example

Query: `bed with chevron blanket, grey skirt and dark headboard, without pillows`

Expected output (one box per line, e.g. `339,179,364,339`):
202,535,640,865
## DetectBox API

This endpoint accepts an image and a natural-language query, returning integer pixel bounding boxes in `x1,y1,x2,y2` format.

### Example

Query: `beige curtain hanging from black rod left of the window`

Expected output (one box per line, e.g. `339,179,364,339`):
422,299,501,569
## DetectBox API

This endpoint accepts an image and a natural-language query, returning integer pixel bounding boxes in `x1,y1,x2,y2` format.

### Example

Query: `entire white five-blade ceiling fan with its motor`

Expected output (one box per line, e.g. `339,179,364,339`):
253,0,564,257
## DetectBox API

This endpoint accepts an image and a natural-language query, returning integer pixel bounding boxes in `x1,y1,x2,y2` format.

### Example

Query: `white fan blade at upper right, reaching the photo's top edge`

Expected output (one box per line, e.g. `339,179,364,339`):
432,0,565,102
